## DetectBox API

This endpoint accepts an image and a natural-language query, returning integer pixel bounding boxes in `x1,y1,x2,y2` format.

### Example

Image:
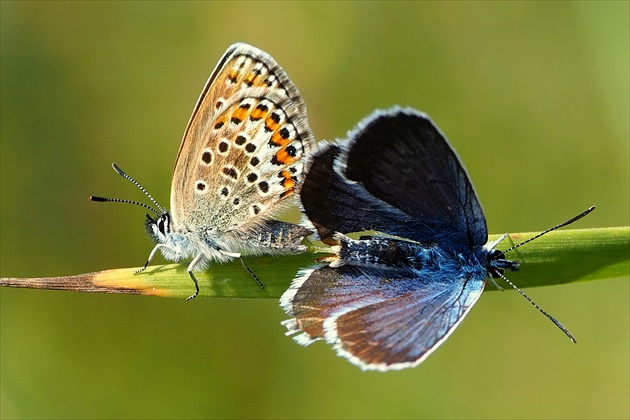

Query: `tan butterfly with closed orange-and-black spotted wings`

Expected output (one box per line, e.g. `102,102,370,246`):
90,43,314,299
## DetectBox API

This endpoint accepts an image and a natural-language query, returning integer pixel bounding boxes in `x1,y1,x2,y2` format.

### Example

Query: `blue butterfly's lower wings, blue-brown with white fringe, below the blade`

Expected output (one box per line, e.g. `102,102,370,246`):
280,266,484,371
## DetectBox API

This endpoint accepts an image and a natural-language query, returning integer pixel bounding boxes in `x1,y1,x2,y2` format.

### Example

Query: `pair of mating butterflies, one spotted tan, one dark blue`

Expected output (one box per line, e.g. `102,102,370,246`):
91,43,591,370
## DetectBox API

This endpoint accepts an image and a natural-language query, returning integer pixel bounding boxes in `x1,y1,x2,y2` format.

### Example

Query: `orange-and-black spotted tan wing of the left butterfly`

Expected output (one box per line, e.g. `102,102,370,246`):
171,44,313,240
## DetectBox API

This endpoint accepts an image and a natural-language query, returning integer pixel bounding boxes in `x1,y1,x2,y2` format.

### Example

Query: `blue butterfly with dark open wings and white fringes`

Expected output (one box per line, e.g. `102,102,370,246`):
280,108,593,371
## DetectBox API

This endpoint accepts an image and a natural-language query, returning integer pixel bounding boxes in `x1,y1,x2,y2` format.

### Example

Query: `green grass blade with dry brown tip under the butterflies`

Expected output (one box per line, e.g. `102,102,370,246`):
0,227,630,299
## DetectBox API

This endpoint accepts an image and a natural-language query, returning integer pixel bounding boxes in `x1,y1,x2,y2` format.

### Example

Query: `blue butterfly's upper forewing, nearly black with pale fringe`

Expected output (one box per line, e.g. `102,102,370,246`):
340,108,487,249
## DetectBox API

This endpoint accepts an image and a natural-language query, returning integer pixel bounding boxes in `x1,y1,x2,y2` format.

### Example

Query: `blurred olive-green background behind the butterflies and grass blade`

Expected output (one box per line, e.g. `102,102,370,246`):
0,1,630,418
